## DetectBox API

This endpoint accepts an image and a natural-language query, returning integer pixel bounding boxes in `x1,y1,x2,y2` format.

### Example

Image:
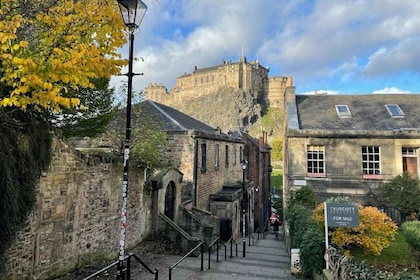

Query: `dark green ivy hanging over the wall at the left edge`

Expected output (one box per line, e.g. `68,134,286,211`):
0,108,51,271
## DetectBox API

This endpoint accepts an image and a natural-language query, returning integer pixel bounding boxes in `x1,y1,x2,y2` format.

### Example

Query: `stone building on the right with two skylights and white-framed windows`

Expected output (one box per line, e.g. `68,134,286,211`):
283,94,420,207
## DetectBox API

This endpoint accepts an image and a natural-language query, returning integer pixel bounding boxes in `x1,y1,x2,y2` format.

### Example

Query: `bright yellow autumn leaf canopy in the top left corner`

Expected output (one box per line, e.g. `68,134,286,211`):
0,0,126,111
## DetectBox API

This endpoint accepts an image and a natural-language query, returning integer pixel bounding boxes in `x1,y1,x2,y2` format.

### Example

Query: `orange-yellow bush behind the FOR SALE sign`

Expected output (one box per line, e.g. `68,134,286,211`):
313,203,398,255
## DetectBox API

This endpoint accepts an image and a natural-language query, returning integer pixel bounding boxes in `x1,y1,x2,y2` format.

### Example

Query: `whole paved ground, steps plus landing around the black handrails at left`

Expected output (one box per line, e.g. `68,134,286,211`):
57,234,296,280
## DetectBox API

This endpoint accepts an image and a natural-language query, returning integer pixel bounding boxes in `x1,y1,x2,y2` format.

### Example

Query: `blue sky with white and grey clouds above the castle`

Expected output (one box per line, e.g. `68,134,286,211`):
111,0,420,94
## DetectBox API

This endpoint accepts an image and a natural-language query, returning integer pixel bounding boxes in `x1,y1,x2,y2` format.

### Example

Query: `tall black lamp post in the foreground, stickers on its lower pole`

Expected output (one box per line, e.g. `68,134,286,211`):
117,0,147,280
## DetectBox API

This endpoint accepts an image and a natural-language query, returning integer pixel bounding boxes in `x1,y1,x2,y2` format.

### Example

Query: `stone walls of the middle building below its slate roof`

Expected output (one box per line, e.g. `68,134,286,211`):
162,131,244,211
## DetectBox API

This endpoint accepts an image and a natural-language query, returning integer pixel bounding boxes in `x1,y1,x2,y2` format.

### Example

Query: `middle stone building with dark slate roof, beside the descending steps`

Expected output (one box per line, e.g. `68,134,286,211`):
144,100,255,241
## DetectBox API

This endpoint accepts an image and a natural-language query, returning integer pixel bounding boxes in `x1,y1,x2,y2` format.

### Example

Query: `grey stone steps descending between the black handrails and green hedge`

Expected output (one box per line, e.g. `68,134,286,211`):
164,235,296,280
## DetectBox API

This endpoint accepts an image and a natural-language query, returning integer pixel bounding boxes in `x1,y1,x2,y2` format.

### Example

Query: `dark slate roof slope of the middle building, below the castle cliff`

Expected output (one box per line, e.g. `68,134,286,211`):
141,100,215,134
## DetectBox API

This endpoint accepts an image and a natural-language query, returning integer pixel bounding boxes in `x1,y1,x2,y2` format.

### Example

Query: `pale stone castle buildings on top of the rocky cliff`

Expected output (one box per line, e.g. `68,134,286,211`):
145,56,295,109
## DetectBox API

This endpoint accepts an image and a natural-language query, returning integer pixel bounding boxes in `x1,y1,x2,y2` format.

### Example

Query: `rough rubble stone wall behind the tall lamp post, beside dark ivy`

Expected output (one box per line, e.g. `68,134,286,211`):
6,139,151,279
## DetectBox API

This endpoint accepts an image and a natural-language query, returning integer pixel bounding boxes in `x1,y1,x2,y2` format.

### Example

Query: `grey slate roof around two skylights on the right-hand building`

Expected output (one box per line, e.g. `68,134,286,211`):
296,94,420,131
